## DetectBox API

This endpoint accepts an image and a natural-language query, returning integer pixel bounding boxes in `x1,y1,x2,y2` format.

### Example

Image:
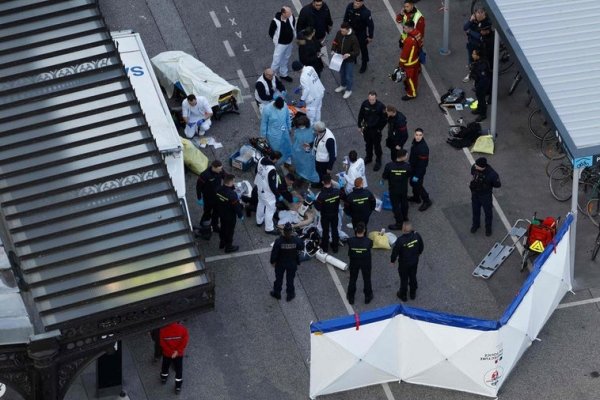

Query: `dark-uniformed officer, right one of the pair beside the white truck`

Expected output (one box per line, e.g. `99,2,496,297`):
217,174,244,253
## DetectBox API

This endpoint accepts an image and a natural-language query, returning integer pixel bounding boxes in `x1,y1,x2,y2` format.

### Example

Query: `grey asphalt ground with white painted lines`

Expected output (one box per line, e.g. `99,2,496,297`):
61,0,600,400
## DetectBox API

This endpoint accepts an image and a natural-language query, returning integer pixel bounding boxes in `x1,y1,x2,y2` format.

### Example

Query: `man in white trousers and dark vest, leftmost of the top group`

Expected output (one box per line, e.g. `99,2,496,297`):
269,6,296,82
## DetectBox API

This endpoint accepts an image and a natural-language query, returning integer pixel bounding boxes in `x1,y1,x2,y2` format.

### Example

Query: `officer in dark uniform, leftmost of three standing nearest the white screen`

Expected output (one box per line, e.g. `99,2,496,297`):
270,222,304,301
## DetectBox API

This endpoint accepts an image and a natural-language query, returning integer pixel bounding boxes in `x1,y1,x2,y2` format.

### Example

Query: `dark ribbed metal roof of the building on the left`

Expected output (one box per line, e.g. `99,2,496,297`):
0,0,212,330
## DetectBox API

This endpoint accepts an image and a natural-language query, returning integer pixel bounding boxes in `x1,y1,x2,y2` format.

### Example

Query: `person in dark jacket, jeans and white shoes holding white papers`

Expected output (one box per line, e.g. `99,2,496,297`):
331,22,360,99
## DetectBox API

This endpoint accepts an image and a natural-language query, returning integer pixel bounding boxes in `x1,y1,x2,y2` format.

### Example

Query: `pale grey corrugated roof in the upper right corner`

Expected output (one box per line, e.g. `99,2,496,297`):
486,0,600,158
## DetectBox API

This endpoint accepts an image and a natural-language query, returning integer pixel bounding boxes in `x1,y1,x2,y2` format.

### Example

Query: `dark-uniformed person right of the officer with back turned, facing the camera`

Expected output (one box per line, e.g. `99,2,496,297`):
408,128,432,211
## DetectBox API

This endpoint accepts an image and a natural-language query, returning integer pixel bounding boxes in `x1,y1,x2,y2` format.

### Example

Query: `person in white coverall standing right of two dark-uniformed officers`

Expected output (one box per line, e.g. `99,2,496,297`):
254,151,281,235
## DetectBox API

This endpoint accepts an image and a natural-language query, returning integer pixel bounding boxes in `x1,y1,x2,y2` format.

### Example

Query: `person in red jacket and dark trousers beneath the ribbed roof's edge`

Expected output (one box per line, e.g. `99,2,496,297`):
160,322,189,394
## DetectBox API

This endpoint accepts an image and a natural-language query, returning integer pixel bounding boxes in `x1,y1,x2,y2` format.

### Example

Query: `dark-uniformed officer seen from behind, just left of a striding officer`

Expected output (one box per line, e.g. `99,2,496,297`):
381,149,412,230
